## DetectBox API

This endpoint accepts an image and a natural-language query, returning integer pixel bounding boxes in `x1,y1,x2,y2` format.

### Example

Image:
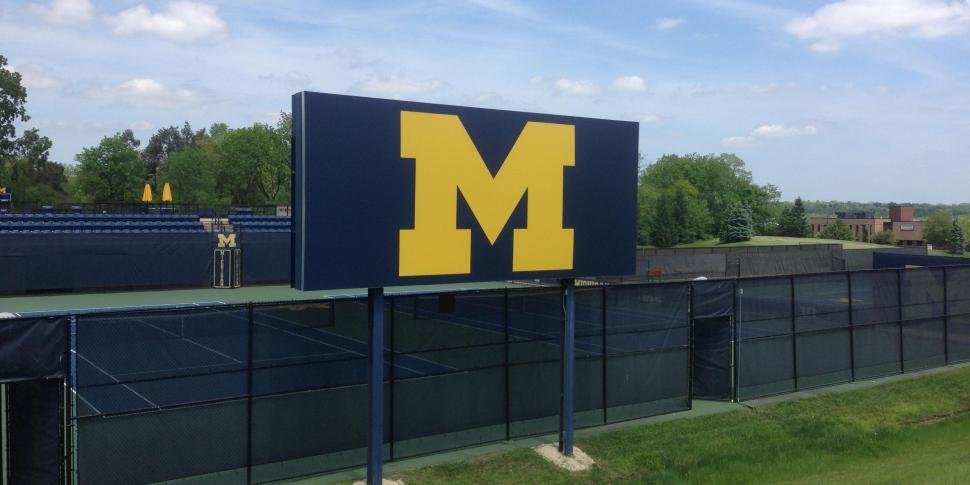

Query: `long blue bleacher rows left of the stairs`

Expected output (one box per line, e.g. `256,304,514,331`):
0,213,205,234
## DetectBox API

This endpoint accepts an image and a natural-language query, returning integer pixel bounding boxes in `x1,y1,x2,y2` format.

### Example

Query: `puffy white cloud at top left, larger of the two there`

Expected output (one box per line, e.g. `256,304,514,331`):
104,1,227,42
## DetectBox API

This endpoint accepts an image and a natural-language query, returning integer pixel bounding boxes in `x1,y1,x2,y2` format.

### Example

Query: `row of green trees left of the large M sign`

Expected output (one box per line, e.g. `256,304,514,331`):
0,55,292,207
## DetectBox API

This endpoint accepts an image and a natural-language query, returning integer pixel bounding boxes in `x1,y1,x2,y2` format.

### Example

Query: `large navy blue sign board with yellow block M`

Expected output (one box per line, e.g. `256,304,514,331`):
292,93,638,290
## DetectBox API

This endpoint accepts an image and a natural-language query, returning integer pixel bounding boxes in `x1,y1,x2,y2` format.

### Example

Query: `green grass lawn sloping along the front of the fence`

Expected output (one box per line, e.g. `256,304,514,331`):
392,367,970,485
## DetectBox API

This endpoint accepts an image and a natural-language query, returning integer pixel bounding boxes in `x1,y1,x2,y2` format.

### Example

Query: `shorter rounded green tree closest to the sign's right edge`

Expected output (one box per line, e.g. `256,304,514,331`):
649,180,711,248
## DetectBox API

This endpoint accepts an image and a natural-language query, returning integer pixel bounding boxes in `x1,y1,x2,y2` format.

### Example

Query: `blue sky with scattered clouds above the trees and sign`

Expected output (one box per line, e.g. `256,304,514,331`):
0,0,970,202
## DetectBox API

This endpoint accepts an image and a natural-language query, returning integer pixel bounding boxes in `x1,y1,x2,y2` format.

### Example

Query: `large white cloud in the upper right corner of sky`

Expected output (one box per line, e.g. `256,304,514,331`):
785,0,970,53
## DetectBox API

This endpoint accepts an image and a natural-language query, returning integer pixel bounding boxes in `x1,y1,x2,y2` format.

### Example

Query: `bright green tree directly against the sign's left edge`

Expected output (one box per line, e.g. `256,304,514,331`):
216,119,290,205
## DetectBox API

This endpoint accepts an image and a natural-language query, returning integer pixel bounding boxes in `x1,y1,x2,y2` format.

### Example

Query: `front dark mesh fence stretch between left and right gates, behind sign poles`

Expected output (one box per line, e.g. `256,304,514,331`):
76,284,690,484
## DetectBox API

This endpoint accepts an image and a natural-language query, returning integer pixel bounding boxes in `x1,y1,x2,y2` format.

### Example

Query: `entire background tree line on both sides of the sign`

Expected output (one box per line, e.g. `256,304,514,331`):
0,55,970,251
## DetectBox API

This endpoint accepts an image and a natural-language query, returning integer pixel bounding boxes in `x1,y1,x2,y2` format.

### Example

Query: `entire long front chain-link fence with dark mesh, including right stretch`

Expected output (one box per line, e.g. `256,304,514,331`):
3,266,970,484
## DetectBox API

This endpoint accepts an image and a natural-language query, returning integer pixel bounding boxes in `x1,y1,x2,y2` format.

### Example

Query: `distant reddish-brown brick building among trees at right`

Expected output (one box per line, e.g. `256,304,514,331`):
809,205,926,246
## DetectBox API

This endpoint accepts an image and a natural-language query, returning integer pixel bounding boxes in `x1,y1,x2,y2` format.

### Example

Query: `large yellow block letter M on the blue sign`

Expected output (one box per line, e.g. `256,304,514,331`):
398,111,576,276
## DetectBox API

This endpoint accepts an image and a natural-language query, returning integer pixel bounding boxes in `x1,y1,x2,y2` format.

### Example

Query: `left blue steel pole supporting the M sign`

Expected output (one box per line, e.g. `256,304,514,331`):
367,288,384,485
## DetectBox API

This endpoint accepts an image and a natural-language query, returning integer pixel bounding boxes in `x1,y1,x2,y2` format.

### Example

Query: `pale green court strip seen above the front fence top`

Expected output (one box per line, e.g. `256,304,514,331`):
0,282,519,314
